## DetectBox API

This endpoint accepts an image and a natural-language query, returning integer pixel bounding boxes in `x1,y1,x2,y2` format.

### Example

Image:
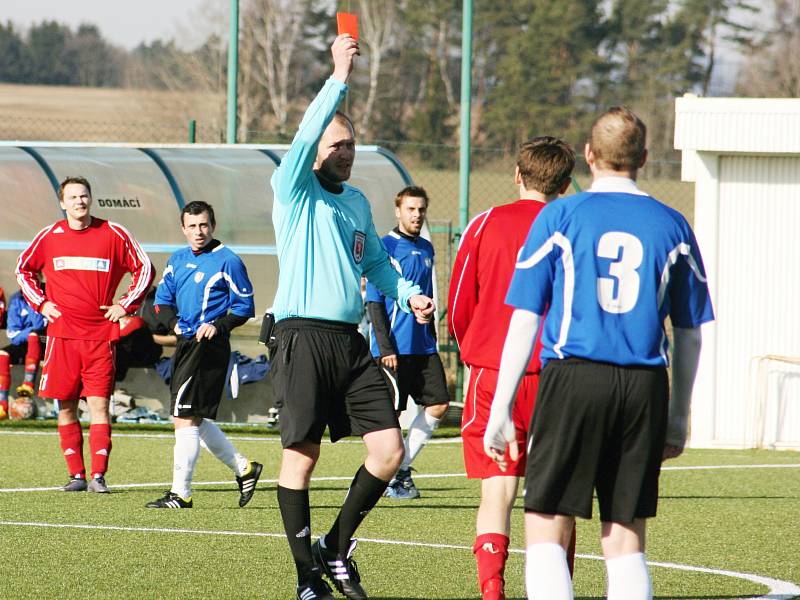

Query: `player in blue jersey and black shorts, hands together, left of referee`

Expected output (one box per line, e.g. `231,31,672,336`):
147,201,262,508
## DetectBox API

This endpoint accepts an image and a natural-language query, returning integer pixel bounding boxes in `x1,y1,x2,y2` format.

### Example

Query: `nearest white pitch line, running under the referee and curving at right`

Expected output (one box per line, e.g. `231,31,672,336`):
0,521,800,600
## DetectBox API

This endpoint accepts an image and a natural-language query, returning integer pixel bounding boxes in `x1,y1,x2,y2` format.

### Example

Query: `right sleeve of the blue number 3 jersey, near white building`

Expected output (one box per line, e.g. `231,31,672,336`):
669,224,714,329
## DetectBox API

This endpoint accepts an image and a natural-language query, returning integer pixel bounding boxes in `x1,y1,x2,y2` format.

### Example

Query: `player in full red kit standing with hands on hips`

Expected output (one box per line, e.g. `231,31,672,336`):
17,177,154,493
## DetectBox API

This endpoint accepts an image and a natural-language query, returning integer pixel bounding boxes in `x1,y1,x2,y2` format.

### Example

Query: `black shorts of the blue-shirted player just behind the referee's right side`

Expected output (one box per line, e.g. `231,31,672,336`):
377,353,450,412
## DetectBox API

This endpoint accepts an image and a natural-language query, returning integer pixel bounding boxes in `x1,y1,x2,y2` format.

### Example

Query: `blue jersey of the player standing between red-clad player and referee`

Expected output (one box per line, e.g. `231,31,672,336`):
155,242,255,338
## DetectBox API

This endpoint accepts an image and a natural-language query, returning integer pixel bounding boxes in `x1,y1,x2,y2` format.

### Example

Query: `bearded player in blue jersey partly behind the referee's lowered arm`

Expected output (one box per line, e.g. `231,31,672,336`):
366,186,450,499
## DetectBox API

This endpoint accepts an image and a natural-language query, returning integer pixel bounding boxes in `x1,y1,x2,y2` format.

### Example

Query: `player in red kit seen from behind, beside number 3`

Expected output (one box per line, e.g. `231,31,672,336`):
447,136,575,600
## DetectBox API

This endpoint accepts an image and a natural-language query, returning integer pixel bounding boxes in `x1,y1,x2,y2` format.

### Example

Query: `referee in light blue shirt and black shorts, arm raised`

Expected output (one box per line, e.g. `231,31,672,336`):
270,34,433,600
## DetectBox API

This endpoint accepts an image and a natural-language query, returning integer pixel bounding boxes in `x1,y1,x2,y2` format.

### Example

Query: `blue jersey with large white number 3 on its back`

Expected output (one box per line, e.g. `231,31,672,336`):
506,185,714,366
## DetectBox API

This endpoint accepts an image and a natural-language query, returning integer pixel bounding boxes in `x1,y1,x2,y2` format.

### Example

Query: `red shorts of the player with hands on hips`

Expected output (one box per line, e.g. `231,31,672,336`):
39,337,116,400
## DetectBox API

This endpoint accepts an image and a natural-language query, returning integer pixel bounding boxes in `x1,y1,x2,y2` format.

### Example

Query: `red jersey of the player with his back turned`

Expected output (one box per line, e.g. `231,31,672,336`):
447,200,545,373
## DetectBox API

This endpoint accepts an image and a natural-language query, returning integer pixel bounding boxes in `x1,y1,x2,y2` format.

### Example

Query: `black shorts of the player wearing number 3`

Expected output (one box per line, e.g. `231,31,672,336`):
525,358,669,523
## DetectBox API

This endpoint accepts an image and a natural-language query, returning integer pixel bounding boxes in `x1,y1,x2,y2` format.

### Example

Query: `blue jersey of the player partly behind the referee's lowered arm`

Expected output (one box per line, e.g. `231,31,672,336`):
365,231,437,357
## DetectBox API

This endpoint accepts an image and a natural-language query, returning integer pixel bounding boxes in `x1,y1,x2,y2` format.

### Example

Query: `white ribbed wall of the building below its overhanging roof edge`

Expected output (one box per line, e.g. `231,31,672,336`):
714,156,800,446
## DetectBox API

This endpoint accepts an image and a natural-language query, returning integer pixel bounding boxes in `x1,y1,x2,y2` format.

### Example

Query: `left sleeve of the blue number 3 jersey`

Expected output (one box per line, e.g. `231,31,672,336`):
506,211,561,315
